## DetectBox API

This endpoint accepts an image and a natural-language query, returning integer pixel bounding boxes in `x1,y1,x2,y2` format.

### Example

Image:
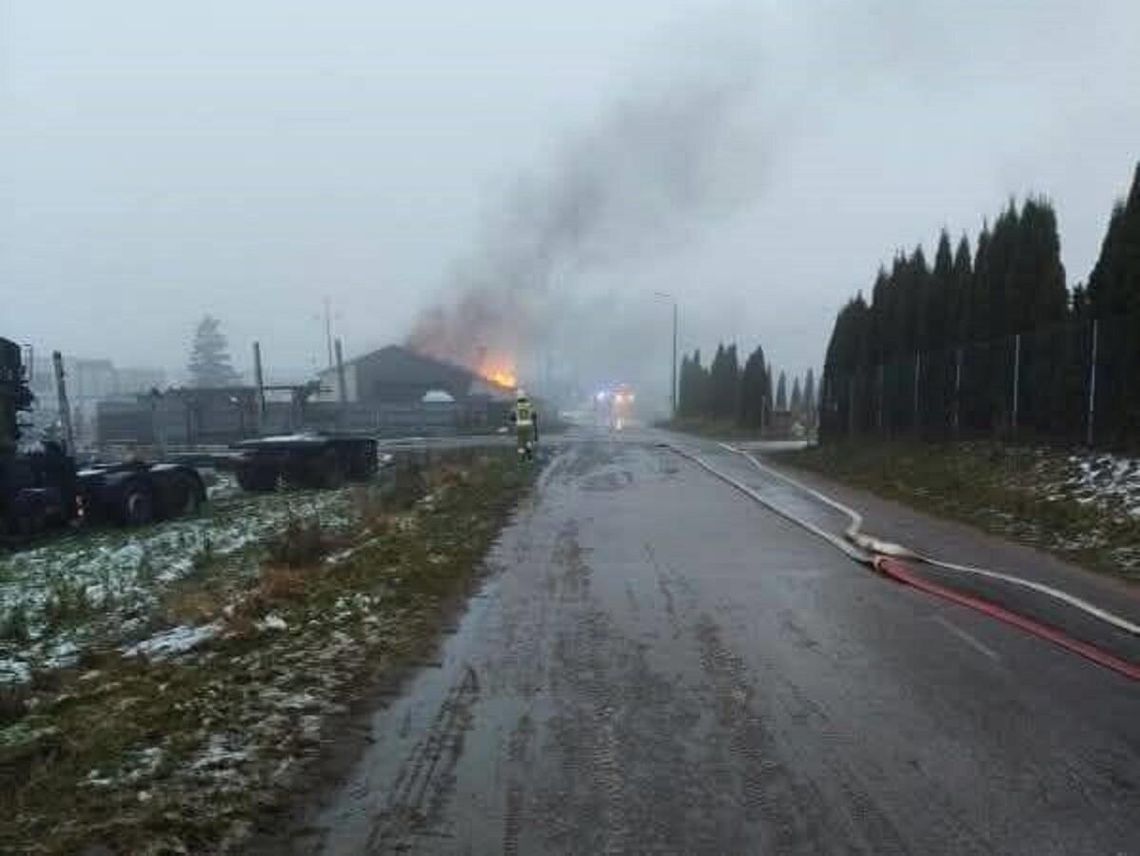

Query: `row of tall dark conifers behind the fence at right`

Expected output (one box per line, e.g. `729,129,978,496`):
820,165,1140,442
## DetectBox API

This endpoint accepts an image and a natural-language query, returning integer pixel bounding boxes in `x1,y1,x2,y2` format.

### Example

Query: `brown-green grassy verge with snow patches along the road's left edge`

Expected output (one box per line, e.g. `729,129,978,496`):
0,451,537,854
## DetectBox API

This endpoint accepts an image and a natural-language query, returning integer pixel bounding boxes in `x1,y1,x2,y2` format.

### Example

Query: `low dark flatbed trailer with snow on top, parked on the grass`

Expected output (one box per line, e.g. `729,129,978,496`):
228,433,380,491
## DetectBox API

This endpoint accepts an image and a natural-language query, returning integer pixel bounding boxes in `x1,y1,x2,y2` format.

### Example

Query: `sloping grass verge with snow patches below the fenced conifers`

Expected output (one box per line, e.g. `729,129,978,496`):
777,441,1140,581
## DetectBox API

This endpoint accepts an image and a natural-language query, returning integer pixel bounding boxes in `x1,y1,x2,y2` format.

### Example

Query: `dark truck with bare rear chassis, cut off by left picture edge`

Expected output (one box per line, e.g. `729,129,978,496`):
0,339,205,539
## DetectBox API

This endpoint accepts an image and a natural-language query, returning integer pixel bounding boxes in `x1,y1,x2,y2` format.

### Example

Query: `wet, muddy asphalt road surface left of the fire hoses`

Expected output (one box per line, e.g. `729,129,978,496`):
292,434,1140,856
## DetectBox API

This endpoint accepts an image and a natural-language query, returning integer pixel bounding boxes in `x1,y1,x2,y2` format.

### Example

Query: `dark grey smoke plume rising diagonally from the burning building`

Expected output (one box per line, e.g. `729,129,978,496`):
408,29,760,385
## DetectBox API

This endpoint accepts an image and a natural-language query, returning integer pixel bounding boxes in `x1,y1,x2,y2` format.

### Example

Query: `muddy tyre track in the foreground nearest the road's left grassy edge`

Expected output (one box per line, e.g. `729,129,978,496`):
366,666,480,854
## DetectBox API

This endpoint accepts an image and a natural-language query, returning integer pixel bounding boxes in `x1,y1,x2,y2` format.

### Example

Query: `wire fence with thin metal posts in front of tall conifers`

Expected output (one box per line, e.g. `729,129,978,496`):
820,316,1140,447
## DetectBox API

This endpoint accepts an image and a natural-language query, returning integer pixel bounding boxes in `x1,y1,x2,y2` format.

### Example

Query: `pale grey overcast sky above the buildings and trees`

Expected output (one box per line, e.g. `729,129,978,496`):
0,0,1140,387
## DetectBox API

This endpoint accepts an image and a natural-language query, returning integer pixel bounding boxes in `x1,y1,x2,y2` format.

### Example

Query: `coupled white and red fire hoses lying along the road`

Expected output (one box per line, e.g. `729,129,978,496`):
661,443,1140,680
